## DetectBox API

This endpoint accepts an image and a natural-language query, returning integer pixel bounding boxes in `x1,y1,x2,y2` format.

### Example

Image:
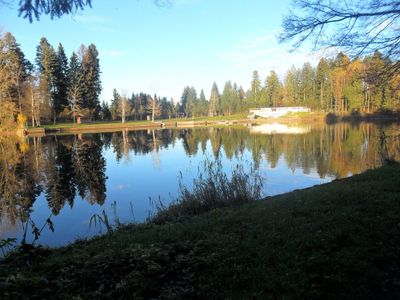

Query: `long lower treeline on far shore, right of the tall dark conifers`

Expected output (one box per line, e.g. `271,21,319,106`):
111,52,400,119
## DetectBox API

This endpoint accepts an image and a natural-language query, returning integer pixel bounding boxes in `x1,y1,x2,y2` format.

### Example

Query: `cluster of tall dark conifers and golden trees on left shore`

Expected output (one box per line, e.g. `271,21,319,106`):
0,32,101,127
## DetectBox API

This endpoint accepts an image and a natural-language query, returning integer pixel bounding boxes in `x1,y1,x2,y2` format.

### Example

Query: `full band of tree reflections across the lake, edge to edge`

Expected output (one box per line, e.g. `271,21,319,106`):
0,123,400,224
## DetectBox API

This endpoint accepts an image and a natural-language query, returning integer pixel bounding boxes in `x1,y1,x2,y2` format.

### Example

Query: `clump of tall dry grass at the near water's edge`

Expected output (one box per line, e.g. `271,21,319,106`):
150,159,263,224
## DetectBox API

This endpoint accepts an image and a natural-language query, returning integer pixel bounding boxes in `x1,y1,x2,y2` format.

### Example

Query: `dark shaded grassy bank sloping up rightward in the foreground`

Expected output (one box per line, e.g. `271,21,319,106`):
0,164,400,299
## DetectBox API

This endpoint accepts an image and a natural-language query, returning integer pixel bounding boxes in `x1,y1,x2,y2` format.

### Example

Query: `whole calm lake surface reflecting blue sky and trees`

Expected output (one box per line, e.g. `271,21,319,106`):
0,123,400,246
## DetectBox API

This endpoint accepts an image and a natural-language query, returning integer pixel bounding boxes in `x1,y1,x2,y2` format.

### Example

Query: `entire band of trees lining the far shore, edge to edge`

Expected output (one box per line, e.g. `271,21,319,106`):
0,32,400,129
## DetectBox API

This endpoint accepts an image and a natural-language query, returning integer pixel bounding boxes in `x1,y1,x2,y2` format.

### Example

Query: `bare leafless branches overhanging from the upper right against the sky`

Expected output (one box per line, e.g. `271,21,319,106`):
280,0,400,58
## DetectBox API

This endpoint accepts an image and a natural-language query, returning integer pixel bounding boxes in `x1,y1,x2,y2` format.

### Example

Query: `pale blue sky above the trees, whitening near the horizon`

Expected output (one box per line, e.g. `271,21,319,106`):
0,0,318,101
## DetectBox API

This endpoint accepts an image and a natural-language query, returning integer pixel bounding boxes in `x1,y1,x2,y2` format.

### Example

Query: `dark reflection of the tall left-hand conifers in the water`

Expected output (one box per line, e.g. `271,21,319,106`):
0,135,106,224
